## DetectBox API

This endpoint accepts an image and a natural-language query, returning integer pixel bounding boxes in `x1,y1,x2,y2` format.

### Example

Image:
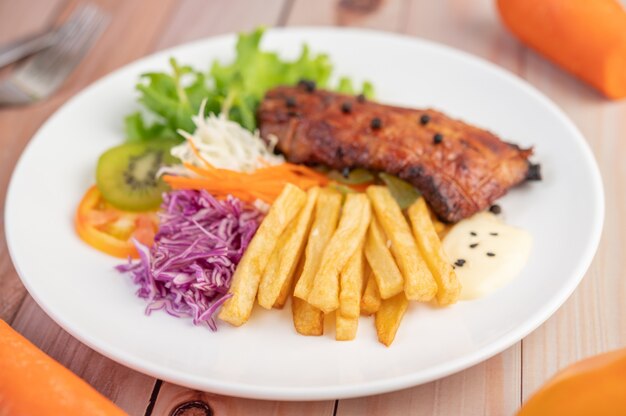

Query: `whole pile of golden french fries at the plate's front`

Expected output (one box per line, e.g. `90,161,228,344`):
219,185,461,346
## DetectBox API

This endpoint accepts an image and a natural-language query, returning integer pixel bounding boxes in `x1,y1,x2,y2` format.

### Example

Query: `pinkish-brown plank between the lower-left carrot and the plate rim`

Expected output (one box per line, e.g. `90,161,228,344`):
13,296,155,415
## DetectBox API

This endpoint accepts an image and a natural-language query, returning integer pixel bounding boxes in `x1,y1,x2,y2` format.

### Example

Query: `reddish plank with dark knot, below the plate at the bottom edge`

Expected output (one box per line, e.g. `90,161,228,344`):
152,383,335,416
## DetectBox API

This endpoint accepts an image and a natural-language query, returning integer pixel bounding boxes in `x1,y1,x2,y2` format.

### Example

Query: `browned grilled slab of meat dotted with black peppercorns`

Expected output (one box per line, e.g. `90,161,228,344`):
257,85,540,222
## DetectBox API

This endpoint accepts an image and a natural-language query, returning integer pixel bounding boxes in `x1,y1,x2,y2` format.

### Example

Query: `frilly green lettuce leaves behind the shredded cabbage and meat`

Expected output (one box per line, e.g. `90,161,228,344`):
125,28,373,142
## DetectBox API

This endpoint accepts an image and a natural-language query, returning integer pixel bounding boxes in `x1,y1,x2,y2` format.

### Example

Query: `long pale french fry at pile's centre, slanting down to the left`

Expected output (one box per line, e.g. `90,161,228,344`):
307,194,372,313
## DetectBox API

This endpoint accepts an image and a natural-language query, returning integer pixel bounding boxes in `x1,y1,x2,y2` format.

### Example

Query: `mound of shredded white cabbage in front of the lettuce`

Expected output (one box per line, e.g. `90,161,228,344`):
171,102,285,172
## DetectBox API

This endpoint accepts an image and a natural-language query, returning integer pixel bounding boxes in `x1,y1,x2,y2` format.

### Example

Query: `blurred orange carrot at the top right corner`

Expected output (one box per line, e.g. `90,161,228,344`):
497,0,626,98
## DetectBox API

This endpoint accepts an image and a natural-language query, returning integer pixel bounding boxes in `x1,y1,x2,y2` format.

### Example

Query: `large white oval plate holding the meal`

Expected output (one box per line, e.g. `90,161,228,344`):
6,29,604,400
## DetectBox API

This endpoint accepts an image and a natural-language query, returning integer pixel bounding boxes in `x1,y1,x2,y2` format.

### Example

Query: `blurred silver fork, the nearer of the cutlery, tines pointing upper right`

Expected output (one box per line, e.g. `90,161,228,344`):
0,4,109,105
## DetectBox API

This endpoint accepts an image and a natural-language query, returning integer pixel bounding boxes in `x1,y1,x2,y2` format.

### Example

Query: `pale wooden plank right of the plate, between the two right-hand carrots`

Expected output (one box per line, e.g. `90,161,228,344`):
522,52,626,400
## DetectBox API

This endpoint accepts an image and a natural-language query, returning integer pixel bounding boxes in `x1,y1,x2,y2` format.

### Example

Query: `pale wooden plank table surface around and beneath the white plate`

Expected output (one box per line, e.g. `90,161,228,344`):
0,0,626,416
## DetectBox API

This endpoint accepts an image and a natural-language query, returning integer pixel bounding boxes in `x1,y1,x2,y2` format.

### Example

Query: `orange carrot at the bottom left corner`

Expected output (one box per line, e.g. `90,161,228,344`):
0,320,126,416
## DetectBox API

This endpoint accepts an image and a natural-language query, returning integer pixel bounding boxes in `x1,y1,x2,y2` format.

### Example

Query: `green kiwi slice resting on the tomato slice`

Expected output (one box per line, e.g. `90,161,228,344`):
96,142,178,211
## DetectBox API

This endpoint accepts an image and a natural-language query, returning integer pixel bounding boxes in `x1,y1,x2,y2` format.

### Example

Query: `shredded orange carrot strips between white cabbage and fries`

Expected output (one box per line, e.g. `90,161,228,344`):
163,161,329,203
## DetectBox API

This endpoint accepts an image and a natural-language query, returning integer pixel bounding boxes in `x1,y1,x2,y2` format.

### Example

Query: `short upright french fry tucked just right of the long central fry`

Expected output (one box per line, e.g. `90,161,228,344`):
337,243,364,318
